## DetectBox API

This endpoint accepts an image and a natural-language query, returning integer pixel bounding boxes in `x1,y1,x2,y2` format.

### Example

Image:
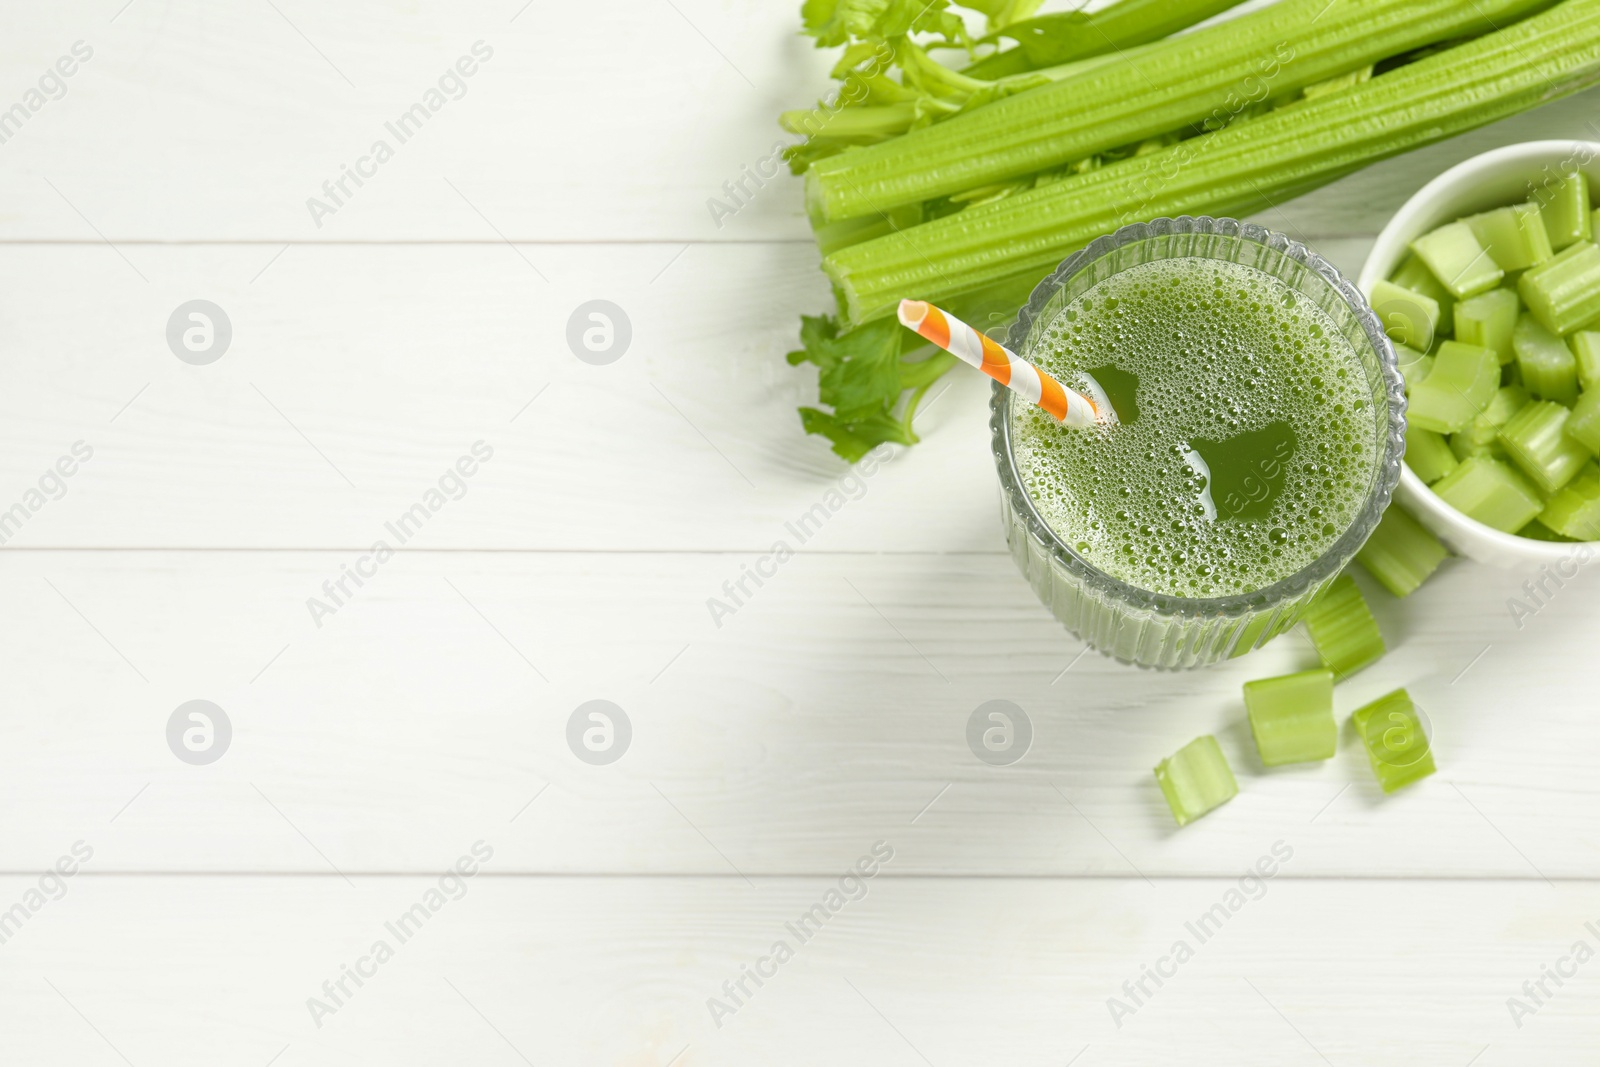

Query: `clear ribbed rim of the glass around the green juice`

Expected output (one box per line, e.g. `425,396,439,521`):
989,214,1406,617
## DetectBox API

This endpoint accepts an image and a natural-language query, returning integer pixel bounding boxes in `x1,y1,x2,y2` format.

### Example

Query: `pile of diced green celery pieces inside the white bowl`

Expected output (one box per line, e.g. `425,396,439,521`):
1370,170,1600,541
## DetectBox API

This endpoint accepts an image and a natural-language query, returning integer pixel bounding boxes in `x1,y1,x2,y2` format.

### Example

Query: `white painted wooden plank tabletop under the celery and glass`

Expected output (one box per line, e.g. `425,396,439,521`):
0,0,1600,1067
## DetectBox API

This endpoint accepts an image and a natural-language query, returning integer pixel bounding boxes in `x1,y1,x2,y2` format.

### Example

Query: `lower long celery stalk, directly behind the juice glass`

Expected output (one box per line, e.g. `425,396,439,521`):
822,0,1600,323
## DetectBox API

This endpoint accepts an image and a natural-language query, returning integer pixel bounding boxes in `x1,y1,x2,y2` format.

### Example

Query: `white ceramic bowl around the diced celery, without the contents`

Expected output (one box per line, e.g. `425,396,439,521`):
1357,141,1600,569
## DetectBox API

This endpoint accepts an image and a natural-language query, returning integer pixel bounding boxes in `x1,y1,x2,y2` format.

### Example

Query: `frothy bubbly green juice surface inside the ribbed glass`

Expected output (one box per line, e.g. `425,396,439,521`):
1011,258,1379,598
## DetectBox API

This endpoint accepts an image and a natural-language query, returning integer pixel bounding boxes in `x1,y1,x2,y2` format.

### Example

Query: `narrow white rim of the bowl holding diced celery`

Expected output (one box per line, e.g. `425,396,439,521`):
1357,138,1600,563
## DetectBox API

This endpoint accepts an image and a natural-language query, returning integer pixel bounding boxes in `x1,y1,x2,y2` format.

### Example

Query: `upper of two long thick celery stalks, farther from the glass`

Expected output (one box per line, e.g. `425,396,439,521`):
806,0,1549,224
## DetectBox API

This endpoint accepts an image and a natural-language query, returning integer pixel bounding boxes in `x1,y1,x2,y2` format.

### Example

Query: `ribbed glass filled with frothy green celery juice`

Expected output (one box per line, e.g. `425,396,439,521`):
990,218,1405,667
